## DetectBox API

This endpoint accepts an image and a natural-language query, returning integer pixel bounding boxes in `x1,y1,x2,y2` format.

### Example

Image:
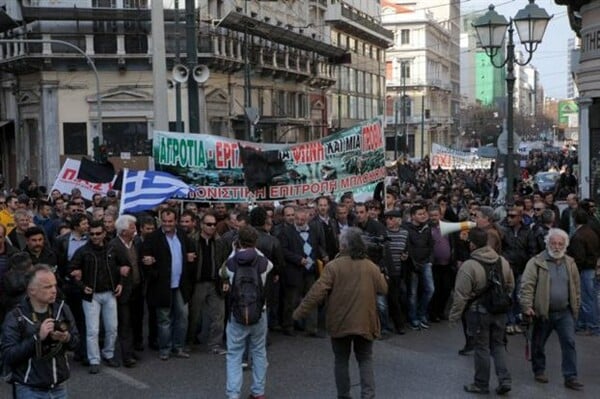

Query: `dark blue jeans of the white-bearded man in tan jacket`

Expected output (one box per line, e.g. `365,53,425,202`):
531,309,577,380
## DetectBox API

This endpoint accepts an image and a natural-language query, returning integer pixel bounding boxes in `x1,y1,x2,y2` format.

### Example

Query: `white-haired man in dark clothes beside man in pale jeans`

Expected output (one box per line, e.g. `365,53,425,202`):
108,215,143,367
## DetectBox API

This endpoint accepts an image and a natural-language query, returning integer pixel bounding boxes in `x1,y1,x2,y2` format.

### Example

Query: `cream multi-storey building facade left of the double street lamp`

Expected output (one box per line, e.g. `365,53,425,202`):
382,0,461,157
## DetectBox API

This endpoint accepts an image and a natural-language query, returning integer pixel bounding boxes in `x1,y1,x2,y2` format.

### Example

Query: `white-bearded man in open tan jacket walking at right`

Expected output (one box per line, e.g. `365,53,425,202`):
519,228,583,391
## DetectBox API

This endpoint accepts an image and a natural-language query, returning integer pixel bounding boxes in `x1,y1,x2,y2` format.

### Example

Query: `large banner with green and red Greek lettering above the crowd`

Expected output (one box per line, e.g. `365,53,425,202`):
153,119,386,202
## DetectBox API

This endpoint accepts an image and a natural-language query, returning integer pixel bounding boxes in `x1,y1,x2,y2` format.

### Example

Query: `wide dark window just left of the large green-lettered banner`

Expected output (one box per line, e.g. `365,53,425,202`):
102,122,148,156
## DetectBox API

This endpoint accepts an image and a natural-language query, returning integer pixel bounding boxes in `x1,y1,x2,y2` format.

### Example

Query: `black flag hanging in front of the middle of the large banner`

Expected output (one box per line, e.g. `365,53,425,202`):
240,145,287,191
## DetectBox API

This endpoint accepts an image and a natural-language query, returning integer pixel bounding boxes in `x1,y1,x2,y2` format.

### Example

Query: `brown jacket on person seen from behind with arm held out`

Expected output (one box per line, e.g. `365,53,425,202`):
293,255,387,340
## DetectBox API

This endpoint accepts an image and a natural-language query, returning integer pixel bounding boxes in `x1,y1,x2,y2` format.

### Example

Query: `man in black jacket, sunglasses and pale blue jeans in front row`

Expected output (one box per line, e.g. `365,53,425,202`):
70,220,123,374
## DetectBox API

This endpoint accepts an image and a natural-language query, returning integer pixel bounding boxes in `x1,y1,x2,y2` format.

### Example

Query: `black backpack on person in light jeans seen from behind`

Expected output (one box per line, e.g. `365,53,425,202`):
230,254,265,326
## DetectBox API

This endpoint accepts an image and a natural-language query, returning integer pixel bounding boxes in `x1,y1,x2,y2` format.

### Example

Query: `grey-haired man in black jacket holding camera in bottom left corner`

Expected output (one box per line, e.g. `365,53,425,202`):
0,264,79,399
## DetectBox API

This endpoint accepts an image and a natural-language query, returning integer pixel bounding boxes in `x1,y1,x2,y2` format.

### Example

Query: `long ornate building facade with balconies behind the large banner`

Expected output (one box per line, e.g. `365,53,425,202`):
0,0,392,186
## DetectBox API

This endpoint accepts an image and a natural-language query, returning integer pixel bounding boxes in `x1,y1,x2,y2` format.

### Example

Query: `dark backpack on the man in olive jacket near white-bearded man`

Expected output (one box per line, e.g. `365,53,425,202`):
477,258,512,314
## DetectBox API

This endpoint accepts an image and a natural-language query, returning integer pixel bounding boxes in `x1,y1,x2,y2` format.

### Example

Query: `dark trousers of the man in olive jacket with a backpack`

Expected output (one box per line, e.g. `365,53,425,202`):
467,310,511,389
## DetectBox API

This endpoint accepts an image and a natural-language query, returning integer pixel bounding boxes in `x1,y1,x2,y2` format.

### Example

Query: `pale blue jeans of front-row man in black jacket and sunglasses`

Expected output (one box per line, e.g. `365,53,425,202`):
82,291,118,365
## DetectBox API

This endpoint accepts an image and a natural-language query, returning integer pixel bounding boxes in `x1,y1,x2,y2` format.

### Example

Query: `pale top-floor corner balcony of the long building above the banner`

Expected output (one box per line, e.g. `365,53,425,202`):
325,3,394,48
